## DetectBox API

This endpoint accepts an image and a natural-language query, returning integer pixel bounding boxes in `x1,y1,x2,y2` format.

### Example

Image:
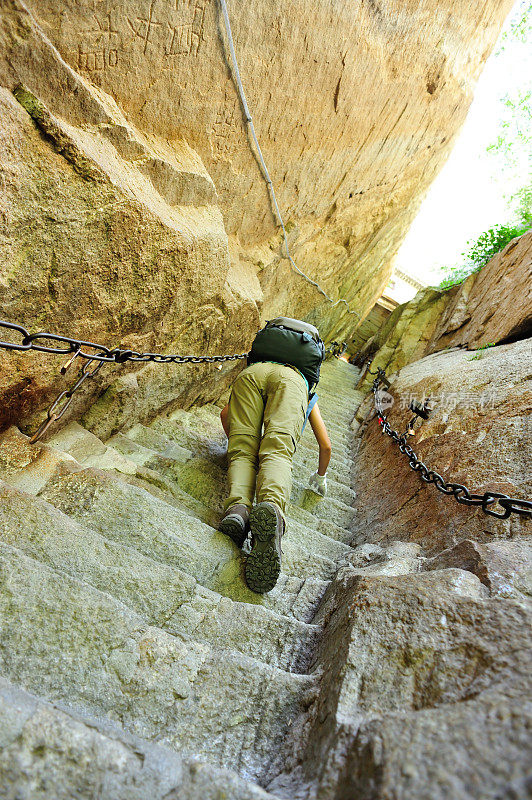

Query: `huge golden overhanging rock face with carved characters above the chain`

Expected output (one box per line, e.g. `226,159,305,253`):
0,0,511,432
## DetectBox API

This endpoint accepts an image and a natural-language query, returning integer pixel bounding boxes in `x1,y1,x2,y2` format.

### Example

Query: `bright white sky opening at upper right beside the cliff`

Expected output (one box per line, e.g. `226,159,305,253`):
396,2,532,285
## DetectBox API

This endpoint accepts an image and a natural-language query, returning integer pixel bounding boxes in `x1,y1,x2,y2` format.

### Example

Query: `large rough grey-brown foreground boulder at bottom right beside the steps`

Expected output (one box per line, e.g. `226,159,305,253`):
270,567,531,800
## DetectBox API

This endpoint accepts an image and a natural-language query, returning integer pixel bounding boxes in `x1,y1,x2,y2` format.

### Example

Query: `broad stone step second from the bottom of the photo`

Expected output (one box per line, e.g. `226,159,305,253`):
0,544,316,782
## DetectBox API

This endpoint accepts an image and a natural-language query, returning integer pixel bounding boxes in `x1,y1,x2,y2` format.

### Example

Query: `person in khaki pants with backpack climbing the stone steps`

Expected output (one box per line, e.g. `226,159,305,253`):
218,317,331,594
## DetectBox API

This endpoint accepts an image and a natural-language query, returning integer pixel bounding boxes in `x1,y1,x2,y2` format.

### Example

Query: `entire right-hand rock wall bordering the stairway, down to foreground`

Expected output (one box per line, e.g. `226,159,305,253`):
328,268,532,800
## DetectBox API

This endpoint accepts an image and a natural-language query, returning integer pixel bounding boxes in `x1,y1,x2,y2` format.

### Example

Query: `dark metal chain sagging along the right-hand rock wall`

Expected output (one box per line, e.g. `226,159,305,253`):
368,367,532,519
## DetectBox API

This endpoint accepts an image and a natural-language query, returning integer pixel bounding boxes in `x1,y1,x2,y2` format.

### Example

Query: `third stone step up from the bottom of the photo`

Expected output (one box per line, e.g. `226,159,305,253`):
0,483,320,672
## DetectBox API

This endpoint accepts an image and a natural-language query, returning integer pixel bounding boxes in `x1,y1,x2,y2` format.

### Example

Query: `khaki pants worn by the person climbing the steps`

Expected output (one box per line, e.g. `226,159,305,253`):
225,362,308,514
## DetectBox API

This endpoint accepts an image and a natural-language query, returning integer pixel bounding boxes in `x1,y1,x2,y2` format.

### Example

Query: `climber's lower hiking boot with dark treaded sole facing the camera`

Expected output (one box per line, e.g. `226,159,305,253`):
245,501,284,594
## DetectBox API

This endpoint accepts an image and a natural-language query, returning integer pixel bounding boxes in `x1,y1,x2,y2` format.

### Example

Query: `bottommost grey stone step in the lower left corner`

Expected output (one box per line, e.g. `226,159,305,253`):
0,678,275,800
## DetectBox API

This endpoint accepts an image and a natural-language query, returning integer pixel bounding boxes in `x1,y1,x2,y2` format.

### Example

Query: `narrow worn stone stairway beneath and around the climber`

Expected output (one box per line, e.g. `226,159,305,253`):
0,359,364,798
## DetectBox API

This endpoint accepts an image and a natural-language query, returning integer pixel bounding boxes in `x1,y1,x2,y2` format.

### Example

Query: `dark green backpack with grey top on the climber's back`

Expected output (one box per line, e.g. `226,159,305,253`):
248,317,325,391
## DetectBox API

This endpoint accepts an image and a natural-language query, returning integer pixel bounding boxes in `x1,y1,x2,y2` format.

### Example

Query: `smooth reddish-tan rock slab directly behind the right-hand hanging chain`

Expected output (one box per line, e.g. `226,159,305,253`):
355,340,532,554
